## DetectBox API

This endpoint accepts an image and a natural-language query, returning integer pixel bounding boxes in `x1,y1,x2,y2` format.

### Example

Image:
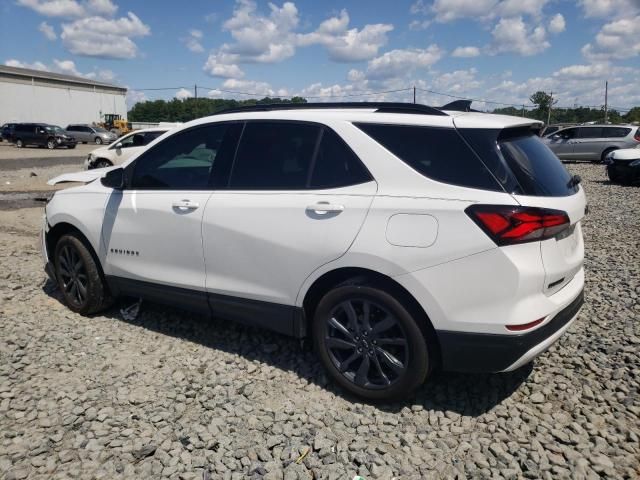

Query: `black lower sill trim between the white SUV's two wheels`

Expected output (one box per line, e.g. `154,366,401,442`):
106,276,307,338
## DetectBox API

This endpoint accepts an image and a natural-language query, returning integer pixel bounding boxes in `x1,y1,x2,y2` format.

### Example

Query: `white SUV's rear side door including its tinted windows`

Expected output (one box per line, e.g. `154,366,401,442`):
203,121,377,333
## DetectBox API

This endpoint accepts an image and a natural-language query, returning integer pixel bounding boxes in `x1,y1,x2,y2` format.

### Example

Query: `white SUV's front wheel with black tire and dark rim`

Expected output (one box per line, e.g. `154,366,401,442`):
53,233,112,315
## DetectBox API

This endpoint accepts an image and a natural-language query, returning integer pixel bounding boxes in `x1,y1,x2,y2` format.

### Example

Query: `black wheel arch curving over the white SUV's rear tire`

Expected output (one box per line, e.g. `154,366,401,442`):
302,267,442,366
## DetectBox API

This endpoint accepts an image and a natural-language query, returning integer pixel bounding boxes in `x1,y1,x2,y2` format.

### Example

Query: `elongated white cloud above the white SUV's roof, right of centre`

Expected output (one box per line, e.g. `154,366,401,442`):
367,45,444,79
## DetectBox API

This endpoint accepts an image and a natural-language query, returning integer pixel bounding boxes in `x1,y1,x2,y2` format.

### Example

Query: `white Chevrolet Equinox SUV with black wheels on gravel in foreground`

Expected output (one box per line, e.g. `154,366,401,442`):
43,103,586,400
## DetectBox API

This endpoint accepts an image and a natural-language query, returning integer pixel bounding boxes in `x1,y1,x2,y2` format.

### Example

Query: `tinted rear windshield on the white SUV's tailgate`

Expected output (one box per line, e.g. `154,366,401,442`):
459,128,578,197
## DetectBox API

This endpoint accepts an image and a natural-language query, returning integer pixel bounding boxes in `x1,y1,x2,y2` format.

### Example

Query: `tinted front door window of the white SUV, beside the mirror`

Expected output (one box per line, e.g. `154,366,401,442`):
131,124,235,190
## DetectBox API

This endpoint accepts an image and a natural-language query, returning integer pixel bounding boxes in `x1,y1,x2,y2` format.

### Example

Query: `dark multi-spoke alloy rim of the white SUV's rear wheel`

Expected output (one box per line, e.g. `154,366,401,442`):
325,299,409,389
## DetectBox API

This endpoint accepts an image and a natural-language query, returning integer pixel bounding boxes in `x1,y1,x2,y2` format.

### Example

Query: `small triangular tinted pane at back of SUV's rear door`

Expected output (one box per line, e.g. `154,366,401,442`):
309,128,371,188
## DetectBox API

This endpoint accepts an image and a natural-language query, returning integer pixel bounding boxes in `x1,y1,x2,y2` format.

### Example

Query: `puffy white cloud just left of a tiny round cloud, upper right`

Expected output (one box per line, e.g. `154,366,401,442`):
491,17,551,56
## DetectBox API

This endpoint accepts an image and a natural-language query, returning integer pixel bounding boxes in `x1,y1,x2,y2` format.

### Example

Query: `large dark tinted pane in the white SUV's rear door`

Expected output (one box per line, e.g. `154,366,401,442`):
229,122,322,190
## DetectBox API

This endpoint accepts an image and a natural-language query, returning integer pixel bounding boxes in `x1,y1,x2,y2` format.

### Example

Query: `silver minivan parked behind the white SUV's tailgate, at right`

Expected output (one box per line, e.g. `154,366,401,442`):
544,125,640,162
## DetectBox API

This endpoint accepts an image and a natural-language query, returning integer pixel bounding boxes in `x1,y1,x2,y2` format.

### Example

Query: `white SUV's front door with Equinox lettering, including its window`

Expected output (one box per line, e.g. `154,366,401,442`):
103,125,235,312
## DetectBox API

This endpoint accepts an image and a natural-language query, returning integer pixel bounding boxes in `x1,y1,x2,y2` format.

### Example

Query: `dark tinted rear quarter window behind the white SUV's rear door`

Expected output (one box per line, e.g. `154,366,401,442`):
355,123,502,191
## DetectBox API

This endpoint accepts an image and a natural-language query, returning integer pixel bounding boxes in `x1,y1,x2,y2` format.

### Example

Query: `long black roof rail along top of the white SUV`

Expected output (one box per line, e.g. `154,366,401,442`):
214,102,447,116
